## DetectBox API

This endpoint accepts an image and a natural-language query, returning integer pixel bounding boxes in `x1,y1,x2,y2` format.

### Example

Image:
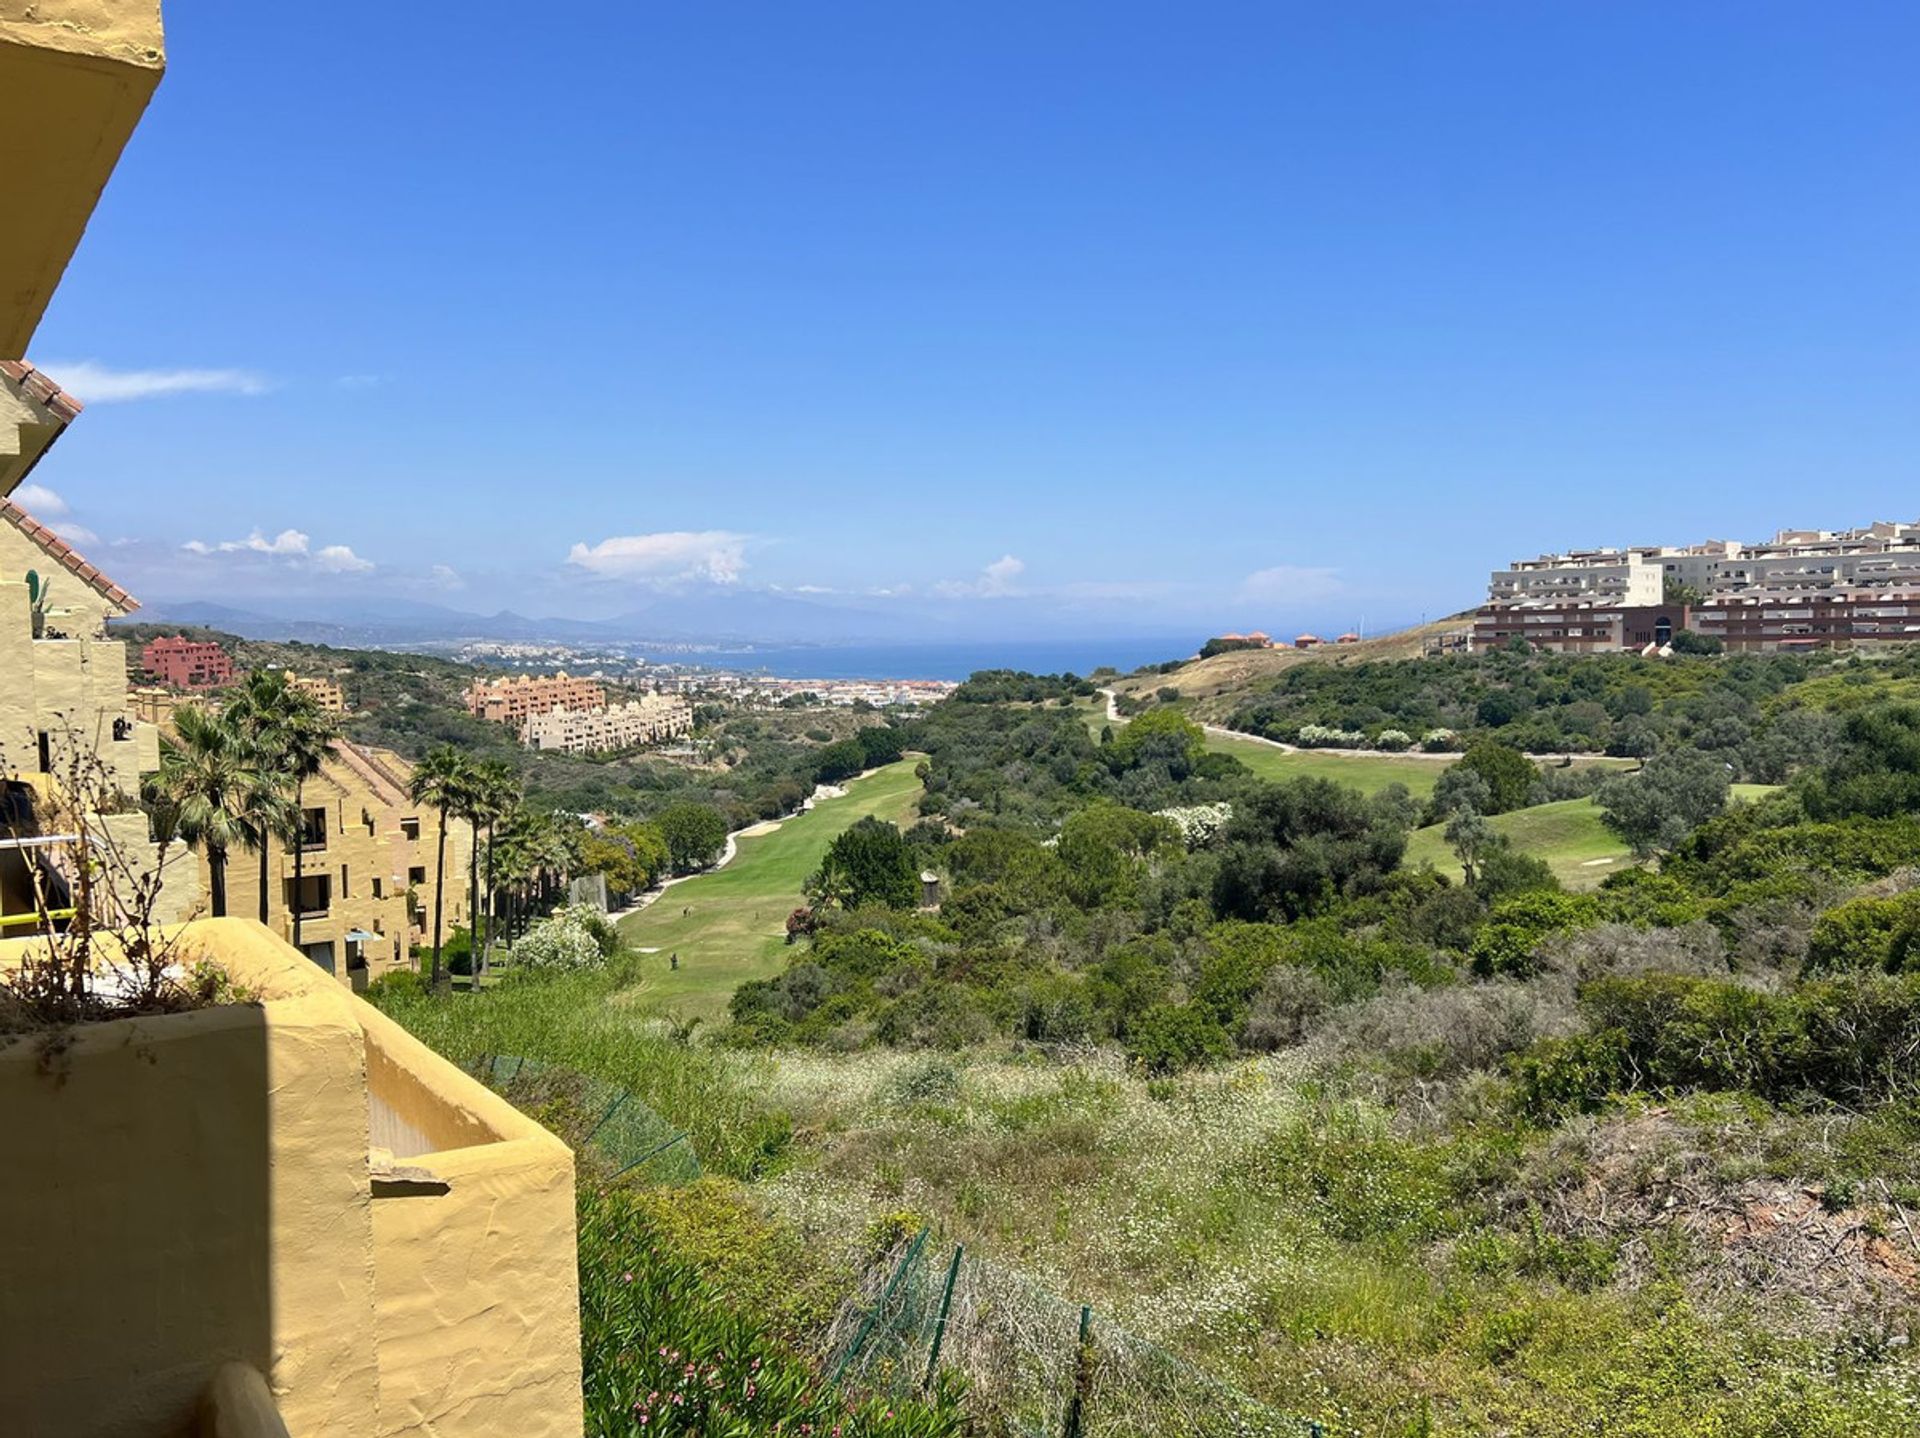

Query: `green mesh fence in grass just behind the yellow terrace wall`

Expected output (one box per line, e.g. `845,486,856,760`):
468,1054,701,1186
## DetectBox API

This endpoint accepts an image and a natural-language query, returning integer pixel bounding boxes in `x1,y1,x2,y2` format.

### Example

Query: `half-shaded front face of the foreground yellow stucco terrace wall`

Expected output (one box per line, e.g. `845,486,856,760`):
0,931,378,1438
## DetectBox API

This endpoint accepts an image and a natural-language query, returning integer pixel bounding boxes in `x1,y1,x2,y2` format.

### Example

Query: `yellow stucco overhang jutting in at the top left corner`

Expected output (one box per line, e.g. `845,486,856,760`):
0,0,165,357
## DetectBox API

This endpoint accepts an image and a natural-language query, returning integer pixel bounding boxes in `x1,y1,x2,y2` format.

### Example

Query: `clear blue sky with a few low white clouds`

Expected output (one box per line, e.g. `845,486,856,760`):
18,0,1920,637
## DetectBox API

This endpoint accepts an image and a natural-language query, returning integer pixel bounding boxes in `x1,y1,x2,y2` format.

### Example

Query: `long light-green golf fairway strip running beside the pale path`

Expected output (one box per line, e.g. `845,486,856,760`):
620,755,920,1019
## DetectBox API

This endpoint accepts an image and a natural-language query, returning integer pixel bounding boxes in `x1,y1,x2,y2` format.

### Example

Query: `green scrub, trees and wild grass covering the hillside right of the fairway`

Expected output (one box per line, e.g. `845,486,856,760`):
374,653,1920,1438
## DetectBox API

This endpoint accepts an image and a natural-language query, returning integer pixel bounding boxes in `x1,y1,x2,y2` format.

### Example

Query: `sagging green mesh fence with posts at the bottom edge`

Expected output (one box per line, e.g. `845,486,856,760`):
829,1231,1321,1438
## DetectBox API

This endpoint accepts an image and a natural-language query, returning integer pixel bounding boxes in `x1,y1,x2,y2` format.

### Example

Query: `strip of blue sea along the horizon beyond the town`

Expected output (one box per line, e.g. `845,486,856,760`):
630,634,1194,680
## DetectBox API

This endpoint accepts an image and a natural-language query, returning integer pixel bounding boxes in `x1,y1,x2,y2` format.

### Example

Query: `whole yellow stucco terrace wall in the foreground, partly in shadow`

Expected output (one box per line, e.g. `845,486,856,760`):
0,920,582,1438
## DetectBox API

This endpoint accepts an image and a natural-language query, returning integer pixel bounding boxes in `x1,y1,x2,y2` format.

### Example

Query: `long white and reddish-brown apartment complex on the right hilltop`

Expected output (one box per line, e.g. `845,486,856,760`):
1475,520,1920,653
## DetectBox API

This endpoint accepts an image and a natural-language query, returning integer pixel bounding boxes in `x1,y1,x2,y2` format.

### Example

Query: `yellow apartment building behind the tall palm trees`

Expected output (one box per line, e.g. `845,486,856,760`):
200,739,474,991
